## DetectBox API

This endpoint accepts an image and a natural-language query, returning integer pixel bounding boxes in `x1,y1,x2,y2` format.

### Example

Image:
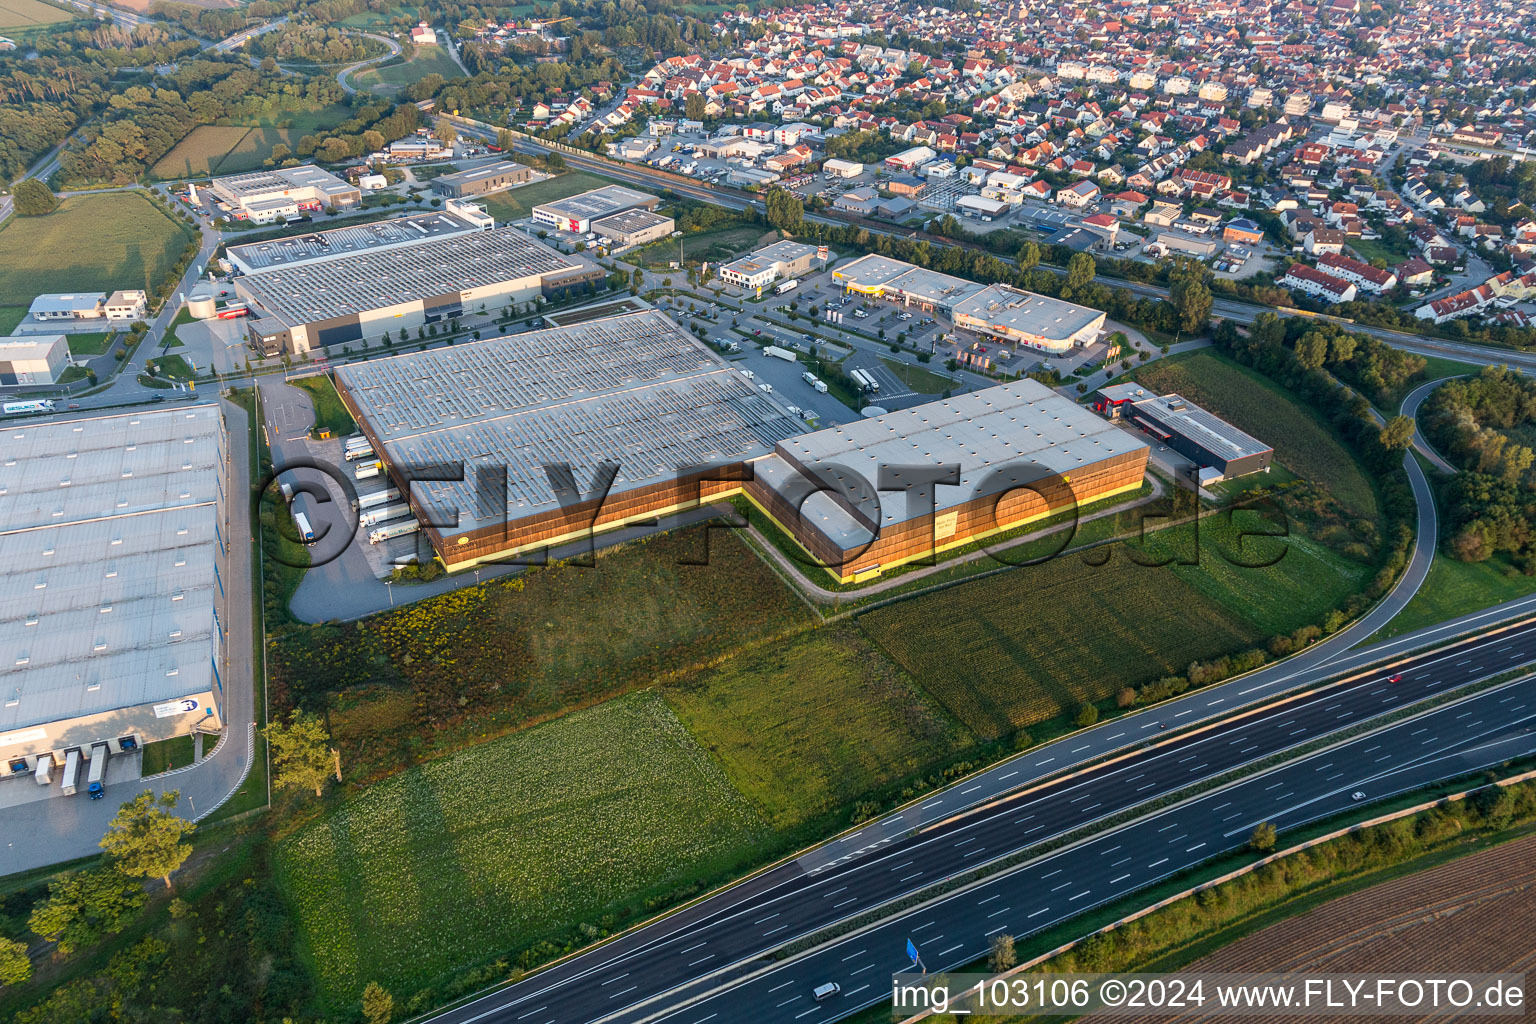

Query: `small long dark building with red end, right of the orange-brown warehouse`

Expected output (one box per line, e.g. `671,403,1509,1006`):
1094,384,1275,484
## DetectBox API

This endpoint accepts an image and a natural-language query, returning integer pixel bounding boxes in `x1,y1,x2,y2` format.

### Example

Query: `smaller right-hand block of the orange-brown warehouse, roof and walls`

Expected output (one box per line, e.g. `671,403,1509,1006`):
745,379,1147,582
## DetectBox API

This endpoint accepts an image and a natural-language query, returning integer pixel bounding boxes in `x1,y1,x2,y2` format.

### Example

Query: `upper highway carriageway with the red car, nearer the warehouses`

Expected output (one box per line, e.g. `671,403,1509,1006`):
435,622,1536,1024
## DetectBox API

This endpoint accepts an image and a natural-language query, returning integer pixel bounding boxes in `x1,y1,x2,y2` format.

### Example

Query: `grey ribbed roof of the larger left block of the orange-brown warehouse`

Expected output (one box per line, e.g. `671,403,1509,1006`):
335,310,800,536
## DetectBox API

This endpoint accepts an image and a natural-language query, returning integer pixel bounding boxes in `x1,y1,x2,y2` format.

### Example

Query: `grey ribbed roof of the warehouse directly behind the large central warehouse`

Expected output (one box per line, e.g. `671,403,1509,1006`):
235,227,591,327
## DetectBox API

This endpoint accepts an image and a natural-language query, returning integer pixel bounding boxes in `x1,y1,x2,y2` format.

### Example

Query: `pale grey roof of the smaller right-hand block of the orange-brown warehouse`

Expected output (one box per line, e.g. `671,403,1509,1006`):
757,378,1147,547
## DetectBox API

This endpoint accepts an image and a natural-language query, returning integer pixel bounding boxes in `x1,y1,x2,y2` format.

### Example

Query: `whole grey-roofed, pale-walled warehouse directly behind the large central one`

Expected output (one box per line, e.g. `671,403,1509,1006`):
233,227,604,355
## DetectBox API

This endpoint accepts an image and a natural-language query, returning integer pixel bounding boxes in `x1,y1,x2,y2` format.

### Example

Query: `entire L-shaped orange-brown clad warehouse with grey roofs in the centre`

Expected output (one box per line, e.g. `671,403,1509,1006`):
335,310,1147,580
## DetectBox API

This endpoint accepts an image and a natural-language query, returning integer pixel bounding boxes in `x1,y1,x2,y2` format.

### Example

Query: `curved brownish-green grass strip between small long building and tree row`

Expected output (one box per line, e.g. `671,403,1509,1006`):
1132,352,1376,517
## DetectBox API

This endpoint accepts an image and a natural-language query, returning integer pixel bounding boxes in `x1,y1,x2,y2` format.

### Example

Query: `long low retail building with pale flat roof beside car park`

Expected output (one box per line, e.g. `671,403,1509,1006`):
833,255,1107,353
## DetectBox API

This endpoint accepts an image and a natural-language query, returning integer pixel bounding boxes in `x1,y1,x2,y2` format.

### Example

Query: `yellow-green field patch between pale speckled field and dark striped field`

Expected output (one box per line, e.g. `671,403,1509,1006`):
664,625,971,829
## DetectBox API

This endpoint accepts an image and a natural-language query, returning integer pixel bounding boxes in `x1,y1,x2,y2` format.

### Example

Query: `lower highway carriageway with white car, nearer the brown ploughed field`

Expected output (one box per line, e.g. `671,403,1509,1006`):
651,679,1536,1024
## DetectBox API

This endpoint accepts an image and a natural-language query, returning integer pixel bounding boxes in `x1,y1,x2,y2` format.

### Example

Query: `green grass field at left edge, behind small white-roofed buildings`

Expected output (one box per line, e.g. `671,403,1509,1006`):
0,192,192,306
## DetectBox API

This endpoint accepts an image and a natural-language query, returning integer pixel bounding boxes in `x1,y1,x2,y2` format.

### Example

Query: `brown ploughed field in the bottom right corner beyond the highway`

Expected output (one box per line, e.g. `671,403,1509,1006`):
1187,838,1536,973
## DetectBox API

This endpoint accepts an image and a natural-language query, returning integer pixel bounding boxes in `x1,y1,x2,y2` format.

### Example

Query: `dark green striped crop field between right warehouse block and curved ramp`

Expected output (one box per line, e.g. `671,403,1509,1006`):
859,513,1372,738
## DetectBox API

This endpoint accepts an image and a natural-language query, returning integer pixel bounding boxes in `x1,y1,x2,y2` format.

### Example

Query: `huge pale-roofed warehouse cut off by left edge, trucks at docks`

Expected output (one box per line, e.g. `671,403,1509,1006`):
0,405,230,785
